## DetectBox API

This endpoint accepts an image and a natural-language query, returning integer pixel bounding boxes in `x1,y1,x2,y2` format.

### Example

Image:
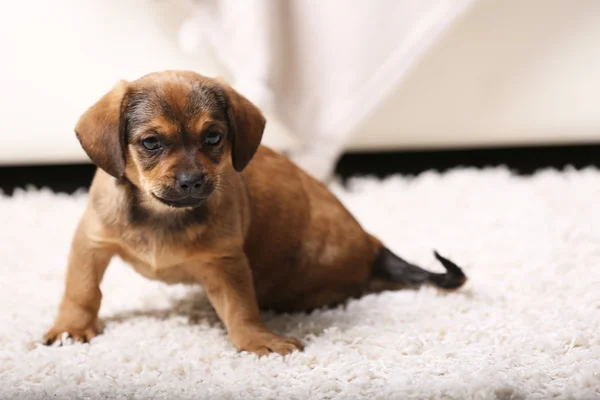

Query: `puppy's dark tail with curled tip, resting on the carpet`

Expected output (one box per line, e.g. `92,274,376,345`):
373,246,467,289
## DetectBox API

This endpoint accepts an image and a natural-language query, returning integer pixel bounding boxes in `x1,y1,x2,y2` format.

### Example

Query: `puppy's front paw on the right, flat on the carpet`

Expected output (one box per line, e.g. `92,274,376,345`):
232,332,304,357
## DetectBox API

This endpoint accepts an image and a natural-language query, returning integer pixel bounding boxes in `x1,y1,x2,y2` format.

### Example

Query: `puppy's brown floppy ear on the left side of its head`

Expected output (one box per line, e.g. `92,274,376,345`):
75,81,129,178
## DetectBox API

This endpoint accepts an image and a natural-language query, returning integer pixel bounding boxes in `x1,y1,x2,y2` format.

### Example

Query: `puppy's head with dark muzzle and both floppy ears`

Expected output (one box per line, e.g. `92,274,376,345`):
75,71,265,208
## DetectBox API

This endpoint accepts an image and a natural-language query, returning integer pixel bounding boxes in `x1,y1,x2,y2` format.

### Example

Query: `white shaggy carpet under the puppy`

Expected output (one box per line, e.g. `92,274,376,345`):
0,168,600,399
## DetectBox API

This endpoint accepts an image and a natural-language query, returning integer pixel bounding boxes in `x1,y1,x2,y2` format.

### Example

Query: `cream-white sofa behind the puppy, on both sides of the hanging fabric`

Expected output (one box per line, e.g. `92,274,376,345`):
0,0,600,165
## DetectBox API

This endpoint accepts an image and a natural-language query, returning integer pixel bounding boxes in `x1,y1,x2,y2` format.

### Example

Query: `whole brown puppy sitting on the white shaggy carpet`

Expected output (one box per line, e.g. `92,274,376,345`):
45,71,466,354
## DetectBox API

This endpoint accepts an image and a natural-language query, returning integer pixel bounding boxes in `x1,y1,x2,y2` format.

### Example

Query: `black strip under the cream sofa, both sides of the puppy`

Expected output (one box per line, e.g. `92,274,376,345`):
0,145,600,194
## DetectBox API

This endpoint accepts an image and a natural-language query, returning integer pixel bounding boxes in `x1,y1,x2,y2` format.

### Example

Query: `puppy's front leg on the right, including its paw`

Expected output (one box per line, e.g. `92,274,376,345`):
191,254,303,356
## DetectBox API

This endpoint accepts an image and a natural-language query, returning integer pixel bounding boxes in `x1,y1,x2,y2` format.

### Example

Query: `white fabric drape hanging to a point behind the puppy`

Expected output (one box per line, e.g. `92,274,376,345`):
180,0,475,179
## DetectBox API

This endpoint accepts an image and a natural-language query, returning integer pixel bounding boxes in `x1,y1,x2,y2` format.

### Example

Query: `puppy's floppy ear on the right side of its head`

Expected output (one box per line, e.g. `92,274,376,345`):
218,83,266,172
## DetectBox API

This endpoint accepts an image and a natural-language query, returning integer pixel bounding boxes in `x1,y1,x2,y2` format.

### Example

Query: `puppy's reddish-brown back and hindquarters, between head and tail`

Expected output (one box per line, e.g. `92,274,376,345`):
238,147,380,301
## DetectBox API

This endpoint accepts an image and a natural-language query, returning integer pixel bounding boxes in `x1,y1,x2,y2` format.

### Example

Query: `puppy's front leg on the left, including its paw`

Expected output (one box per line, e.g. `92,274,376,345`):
44,220,113,344
